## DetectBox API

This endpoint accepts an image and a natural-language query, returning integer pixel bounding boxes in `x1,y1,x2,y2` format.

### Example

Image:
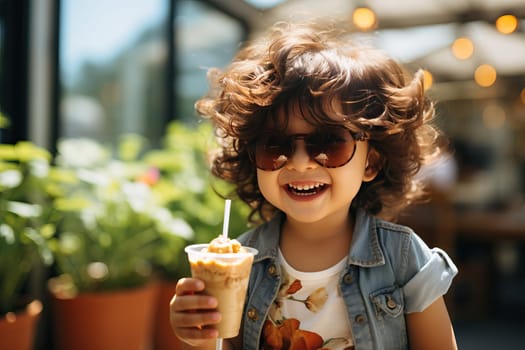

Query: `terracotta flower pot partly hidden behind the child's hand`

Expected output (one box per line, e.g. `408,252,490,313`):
153,280,182,350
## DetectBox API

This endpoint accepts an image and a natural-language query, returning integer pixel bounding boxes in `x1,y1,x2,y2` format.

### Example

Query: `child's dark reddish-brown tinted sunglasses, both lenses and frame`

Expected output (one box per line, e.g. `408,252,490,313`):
255,127,366,171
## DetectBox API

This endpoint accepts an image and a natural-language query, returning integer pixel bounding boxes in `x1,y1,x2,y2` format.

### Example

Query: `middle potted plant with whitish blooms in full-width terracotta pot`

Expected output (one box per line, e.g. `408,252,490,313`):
49,135,191,349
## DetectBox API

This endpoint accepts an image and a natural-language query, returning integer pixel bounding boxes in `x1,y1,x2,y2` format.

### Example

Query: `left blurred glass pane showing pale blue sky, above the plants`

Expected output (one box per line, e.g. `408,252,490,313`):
59,0,169,142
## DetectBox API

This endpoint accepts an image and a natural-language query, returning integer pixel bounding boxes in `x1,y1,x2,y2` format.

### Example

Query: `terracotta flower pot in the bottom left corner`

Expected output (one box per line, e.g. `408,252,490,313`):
0,300,42,350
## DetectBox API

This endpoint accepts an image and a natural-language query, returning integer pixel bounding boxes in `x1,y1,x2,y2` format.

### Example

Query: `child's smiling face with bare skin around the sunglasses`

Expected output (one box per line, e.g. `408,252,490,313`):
257,112,376,223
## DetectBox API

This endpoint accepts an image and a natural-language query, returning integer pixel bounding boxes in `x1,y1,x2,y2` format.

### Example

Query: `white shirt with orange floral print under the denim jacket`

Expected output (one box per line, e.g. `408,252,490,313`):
261,250,354,350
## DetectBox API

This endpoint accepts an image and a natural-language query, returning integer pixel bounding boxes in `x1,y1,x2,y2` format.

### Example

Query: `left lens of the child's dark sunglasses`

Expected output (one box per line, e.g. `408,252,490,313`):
255,134,293,170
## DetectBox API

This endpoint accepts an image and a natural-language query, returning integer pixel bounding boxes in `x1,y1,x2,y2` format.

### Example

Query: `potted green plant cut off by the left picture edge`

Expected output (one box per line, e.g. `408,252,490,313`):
0,133,55,350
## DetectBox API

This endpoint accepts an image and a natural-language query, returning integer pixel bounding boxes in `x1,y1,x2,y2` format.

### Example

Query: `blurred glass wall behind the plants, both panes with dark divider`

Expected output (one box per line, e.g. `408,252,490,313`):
58,0,246,146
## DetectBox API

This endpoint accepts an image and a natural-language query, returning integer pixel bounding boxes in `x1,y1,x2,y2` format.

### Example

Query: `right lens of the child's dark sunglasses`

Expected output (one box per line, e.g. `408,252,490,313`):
306,128,355,168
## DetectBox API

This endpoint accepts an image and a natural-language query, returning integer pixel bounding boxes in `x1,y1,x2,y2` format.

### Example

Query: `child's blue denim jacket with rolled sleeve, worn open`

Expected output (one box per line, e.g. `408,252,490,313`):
238,210,457,350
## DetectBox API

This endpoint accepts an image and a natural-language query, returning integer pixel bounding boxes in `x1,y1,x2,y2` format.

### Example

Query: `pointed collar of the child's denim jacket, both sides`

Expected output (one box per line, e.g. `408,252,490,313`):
242,209,385,267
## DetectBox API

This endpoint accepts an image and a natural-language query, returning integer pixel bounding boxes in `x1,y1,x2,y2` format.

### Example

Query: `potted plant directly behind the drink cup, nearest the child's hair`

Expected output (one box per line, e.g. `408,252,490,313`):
144,122,248,350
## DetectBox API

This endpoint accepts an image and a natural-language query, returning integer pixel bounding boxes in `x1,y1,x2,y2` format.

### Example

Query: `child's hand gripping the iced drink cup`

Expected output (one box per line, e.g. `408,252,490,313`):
170,278,221,346
